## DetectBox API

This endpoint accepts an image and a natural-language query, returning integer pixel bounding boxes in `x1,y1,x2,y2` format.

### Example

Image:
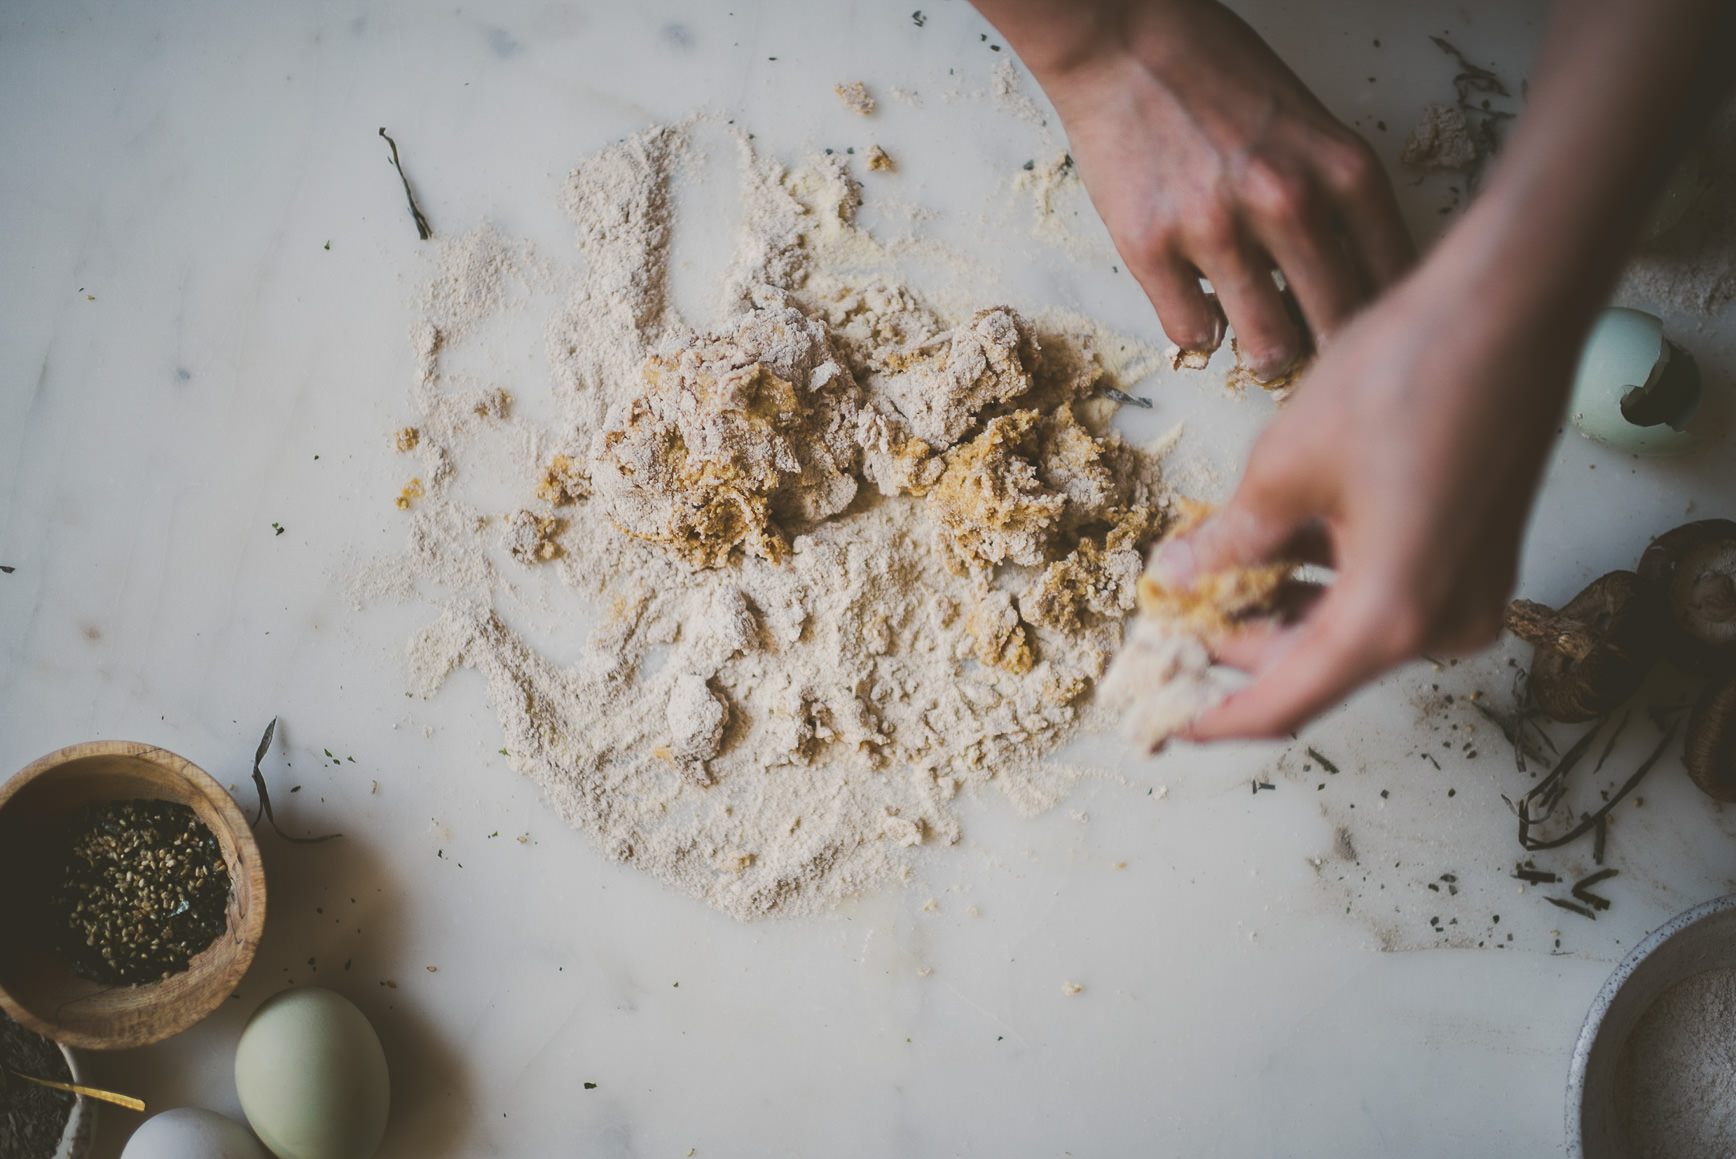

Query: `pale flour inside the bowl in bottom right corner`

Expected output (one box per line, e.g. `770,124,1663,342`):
1616,968,1736,1159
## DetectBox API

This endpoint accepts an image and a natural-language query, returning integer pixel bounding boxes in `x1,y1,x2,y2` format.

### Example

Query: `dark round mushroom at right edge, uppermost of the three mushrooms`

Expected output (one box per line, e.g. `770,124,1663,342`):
1639,519,1736,677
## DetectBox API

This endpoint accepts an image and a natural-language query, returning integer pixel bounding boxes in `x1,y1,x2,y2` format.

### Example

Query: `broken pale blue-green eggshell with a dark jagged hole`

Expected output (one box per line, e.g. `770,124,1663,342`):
1568,307,1700,456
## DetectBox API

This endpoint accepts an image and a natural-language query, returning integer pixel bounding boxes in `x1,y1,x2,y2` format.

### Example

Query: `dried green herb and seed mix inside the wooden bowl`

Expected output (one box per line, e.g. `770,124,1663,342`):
50,800,229,985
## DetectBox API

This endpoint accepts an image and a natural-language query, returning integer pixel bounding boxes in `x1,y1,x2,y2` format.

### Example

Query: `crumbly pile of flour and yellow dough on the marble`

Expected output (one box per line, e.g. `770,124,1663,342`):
363,117,1168,918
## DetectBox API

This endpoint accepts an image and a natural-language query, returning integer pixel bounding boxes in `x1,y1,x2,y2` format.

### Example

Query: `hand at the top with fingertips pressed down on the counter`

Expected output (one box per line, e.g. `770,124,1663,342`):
1020,0,1415,378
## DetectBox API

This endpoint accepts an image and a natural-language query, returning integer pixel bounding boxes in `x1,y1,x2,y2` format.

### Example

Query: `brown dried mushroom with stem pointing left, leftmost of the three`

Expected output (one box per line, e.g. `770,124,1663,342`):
1507,571,1658,722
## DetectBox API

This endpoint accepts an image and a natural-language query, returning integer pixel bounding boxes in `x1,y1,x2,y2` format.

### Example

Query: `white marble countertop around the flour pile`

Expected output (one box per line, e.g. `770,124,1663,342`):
0,0,1736,1159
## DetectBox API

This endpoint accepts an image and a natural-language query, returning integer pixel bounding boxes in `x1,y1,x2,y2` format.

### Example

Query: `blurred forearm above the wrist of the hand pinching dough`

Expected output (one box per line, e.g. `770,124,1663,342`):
1427,0,1733,341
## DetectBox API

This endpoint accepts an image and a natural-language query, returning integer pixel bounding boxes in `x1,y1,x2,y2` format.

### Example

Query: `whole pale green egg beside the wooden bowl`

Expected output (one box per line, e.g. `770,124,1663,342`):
234,987,391,1159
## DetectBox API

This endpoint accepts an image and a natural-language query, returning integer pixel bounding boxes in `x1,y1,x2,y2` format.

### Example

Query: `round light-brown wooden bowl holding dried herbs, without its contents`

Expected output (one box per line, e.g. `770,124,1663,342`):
0,741,266,1050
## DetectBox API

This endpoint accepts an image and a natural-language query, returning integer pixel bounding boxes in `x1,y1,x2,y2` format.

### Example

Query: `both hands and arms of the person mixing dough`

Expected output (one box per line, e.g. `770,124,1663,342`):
976,0,1736,741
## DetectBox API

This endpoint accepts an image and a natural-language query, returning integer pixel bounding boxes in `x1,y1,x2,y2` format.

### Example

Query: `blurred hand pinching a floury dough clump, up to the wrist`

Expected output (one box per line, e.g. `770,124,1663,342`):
1153,253,1580,741
